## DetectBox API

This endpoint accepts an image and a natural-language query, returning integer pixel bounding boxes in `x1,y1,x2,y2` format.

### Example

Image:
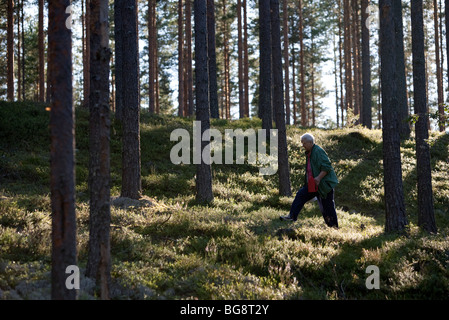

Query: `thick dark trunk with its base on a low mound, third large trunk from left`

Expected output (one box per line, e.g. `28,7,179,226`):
116,0,142,199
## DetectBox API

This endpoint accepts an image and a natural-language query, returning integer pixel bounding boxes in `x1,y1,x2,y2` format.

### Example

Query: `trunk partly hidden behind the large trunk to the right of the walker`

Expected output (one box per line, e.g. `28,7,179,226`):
392,1,410,139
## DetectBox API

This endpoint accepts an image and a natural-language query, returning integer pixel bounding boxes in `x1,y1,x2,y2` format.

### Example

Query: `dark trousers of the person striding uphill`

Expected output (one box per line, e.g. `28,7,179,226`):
290,185,338,228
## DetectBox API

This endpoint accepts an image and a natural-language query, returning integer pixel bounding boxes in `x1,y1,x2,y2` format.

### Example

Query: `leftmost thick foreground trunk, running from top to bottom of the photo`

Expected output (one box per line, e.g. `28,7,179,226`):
48,0,77,300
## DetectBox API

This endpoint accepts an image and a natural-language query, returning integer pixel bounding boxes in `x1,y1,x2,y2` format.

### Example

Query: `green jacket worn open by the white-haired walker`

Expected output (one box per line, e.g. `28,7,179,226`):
304,144,338,199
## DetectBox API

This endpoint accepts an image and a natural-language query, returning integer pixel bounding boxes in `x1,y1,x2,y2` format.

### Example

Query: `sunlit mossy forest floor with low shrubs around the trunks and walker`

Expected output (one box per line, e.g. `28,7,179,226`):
0,103,449,300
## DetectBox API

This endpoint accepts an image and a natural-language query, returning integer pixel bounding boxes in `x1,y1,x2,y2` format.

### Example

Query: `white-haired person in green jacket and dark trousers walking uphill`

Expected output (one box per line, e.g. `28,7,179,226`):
280,133,338,228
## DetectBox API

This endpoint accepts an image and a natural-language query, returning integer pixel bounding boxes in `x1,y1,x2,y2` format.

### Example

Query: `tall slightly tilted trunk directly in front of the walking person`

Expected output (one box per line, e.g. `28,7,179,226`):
270,0,292,196
